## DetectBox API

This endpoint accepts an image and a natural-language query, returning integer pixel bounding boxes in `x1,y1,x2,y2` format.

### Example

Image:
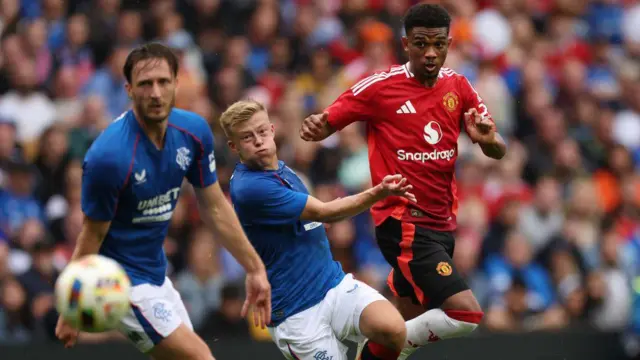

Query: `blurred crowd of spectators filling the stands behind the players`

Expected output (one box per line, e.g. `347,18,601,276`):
0,0,640,354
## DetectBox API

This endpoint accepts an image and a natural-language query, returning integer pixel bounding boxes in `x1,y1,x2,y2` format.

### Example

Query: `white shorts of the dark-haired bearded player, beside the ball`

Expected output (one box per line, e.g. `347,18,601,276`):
118,278,193,353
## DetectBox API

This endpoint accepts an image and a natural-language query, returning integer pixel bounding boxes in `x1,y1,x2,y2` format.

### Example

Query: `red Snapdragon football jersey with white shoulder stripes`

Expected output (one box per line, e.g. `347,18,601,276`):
326,63,491,231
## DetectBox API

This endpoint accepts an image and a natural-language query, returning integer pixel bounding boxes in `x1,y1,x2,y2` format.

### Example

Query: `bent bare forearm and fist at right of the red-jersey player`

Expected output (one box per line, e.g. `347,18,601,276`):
464,108,507,160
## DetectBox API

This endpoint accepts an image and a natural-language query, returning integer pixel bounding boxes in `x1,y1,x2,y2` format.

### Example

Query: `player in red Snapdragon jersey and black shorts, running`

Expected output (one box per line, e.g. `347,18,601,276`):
300,4,506,359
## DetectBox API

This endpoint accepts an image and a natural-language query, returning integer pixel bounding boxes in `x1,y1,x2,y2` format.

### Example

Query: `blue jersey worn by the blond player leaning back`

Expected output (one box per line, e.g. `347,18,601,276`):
230,161,345,326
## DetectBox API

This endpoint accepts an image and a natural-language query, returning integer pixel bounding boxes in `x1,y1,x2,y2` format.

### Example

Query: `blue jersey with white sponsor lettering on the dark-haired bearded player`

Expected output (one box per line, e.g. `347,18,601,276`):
82,109,217,285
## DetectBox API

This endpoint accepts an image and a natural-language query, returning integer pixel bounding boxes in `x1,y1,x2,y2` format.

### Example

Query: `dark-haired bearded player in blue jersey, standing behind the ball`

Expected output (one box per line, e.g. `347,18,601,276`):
56,44,271,360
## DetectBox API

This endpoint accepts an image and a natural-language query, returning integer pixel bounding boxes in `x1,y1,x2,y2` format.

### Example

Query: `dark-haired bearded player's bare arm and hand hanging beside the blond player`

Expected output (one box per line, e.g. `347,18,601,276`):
190,182,271,328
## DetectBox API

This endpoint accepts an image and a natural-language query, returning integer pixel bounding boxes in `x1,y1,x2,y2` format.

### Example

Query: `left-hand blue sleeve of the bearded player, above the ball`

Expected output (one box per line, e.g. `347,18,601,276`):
81,156,122,221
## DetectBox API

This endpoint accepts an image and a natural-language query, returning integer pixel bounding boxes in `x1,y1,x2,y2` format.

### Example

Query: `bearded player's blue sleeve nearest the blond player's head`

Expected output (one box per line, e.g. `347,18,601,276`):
187,118,218,188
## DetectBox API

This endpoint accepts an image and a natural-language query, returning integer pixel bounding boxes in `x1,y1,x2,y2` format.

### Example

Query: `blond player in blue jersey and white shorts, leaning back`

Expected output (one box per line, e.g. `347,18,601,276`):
220,100,415,360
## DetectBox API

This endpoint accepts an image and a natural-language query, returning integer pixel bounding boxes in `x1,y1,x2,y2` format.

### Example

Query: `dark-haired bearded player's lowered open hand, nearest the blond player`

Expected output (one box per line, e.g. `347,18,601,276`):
242,269,271,329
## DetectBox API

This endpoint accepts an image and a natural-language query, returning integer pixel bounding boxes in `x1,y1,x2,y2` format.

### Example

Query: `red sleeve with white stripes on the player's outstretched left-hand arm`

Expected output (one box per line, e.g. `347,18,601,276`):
325,74,380,131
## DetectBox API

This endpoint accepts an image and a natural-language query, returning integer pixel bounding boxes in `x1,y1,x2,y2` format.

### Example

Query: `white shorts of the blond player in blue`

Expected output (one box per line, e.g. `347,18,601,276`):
268,274,386,360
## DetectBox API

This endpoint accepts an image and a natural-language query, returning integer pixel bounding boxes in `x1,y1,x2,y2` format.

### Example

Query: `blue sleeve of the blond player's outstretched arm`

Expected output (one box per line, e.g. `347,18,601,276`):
232,175,309,225
